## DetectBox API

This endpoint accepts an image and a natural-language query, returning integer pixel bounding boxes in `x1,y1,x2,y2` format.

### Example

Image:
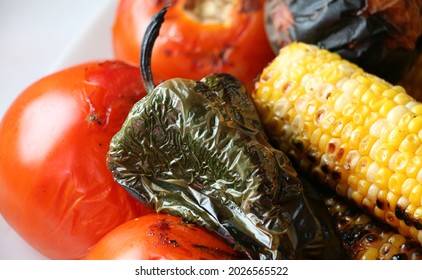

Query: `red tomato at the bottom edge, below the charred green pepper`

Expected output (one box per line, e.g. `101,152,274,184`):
85,213,244,260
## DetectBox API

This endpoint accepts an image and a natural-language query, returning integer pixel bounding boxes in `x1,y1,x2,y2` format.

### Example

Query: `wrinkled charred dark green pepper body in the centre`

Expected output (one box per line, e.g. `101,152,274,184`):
104,7,343,259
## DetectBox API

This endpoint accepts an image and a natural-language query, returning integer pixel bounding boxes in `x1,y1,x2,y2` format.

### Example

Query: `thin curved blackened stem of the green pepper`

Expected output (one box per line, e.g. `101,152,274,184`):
140,7,167,93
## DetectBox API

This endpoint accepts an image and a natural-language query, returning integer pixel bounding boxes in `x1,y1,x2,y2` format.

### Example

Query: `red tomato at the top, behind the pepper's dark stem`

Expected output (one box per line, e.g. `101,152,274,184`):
113,0,274,89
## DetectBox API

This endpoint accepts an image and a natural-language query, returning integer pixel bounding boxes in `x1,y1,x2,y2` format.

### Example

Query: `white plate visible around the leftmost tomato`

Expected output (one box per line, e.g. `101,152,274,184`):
0,0,118,260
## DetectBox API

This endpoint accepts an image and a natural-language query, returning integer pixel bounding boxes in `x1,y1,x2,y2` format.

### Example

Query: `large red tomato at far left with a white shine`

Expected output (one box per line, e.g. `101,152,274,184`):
0,62,150,259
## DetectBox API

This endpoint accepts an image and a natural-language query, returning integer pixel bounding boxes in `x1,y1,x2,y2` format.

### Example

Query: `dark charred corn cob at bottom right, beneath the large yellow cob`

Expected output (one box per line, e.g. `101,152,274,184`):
324,194,422,260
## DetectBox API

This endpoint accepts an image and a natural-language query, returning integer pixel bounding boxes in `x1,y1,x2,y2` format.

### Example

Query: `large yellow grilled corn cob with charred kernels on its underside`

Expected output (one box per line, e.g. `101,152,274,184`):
252,43,422,245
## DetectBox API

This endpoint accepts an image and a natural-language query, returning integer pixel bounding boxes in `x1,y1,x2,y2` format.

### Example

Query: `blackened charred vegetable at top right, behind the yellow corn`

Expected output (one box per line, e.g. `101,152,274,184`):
265,0,422,83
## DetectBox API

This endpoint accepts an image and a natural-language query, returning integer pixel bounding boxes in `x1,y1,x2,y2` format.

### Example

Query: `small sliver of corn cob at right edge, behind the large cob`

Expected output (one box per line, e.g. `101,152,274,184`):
400,55,422,102
